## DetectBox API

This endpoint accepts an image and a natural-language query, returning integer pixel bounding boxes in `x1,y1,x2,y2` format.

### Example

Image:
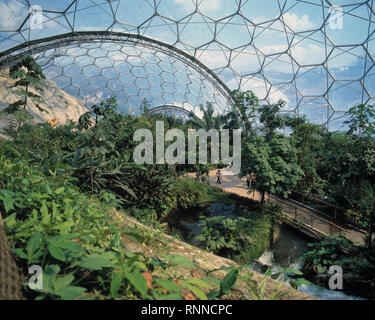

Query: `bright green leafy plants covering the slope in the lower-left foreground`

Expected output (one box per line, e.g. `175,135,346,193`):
0,150,236,300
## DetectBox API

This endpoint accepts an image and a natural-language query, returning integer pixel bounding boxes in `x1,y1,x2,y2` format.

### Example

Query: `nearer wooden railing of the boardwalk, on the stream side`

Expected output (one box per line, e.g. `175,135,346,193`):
268,195,345,236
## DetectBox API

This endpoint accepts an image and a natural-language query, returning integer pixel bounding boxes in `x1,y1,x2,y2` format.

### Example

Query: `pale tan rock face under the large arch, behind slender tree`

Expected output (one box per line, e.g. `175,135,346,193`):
0,70,88,132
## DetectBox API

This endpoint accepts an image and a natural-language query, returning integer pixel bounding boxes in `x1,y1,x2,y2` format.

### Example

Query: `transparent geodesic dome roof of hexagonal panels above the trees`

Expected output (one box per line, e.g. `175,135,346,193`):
0,0,375,129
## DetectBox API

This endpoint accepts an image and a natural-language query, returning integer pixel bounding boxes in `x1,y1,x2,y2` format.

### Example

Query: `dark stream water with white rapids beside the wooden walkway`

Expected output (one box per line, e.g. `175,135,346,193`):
163,201,363,300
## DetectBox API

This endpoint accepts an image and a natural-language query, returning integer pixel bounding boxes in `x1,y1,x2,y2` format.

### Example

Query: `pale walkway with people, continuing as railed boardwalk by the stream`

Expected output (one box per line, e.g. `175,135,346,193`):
188,168,365,245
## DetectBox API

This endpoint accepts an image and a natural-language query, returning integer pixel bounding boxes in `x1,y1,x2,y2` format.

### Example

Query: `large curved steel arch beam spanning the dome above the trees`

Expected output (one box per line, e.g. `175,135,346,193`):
0,31,233,105
